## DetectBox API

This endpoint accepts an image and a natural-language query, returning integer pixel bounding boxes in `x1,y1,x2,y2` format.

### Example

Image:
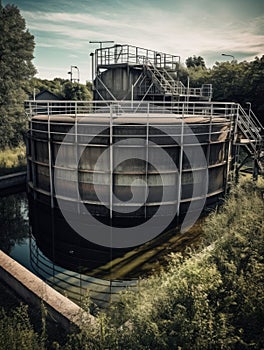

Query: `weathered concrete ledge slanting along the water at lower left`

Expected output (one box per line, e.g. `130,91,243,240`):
0,250,95,330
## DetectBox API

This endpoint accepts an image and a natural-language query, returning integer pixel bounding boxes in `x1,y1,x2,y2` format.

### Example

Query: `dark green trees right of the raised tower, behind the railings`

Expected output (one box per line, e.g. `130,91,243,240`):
180,55,264,125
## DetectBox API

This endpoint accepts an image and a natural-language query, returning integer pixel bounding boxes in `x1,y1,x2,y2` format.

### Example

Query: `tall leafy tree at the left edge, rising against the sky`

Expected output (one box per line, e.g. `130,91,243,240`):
0,3,36,149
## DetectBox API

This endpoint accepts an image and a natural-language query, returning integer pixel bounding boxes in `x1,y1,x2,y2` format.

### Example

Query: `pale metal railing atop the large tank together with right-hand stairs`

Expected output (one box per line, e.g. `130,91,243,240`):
25,100,264,161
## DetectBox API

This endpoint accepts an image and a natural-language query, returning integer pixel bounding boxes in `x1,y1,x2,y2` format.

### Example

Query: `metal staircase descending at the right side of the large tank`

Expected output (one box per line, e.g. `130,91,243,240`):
234,104,264,179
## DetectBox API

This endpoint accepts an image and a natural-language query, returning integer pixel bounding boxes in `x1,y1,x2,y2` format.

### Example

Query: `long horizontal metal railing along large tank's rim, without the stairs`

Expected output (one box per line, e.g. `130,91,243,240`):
25,100,238,121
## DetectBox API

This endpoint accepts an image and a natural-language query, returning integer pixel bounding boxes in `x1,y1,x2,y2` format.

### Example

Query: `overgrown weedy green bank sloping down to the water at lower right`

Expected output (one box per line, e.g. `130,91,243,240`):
0,181,264,350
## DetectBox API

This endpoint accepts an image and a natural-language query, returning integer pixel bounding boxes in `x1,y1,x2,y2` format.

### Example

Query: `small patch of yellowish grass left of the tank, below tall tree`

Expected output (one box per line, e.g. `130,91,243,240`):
0,145,26,176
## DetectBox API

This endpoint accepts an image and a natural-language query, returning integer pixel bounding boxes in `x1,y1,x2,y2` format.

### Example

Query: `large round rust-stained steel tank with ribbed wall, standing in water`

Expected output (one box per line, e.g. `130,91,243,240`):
27,102,231,237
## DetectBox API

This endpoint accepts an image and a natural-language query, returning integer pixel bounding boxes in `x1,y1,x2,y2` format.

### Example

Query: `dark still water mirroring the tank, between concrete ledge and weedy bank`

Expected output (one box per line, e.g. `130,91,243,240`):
0,192,203,307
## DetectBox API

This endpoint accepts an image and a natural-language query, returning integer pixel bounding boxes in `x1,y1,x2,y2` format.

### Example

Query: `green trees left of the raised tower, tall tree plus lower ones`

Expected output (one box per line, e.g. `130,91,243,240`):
0,1,92,150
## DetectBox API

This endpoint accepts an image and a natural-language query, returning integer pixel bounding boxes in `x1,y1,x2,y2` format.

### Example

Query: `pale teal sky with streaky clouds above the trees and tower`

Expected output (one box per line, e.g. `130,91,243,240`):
2,0,264,83
